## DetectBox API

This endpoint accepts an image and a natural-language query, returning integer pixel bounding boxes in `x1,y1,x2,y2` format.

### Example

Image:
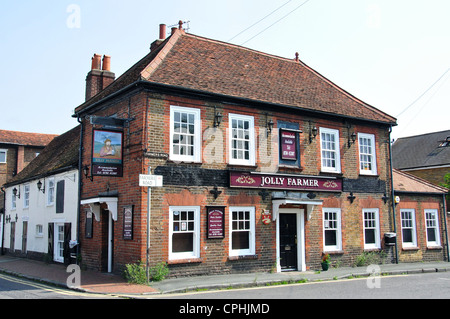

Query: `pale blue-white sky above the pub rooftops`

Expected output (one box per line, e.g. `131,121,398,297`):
0,0,450,138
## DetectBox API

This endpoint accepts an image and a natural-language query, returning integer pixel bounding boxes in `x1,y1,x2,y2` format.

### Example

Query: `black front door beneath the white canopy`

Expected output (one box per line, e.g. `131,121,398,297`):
279,214,298,270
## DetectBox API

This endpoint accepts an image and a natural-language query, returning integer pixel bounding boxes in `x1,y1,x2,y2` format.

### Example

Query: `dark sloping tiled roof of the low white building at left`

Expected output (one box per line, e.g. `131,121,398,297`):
6,125,81,186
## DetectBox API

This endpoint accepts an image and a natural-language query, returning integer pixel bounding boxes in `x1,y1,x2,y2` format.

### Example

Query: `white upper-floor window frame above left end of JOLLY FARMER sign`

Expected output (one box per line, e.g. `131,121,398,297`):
228,113,256,166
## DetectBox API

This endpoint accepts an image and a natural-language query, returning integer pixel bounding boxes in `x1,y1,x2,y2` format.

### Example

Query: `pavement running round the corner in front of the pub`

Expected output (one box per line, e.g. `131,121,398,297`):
0,255,450,298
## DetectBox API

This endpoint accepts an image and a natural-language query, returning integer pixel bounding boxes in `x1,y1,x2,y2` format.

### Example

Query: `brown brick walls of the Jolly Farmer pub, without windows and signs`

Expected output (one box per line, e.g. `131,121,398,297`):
77,91,404,276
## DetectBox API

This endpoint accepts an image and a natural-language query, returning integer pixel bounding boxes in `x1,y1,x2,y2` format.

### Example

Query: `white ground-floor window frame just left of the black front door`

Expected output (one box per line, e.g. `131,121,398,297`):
228,206,256,257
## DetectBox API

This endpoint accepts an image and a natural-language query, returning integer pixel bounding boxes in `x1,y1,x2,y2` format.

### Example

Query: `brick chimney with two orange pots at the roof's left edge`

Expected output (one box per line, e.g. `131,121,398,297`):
86,54,116,101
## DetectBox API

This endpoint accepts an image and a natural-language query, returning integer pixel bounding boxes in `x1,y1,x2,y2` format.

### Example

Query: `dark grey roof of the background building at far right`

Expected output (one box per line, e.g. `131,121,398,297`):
392,130,450,169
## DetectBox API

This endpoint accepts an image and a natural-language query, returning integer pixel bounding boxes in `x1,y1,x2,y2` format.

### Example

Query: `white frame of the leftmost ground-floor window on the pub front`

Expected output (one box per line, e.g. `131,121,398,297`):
169,206,200,260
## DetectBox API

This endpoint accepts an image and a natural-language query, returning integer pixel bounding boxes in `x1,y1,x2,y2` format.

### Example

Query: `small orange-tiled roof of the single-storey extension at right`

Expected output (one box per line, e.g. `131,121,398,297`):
392,169,448,194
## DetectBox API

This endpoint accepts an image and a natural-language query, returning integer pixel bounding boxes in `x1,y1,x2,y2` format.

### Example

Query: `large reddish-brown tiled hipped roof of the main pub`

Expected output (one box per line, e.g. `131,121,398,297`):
75,30,396,125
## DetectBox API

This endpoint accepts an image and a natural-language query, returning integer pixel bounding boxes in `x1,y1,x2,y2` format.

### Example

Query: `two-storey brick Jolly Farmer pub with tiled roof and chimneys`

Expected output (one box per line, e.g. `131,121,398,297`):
73,24,396,277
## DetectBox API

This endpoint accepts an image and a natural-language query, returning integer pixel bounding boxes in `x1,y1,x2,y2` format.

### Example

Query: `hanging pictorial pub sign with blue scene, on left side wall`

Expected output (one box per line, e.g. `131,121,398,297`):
92,129,123,177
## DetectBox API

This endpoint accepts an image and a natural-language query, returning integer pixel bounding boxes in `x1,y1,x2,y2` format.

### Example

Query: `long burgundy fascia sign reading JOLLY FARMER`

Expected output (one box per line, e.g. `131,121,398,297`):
230,171,342,192
